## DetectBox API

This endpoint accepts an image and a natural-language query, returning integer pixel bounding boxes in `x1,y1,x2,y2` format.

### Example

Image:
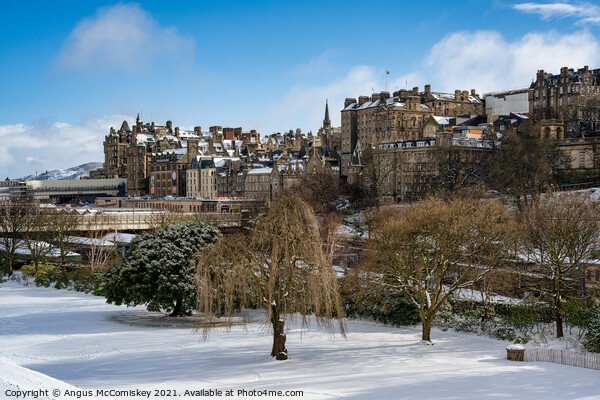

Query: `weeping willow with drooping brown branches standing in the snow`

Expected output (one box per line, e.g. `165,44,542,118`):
196,195,345,360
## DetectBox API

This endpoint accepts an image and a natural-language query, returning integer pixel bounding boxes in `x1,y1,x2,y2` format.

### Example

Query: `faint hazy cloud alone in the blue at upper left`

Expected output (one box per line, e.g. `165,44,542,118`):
55,4,194,71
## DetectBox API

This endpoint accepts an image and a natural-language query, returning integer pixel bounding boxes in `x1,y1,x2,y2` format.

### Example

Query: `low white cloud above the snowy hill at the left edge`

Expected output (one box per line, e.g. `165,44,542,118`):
0,115,133,178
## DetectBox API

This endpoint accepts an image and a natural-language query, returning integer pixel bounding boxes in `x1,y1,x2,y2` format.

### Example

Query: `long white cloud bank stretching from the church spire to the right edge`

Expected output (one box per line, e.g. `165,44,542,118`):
269,30,600,133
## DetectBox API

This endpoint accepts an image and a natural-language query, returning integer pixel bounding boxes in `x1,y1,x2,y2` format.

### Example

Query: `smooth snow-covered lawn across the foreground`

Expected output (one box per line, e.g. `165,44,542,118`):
0,282,600,400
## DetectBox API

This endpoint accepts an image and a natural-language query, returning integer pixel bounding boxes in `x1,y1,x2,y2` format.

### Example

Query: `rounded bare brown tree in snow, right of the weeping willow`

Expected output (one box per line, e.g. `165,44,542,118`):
365,199,512,342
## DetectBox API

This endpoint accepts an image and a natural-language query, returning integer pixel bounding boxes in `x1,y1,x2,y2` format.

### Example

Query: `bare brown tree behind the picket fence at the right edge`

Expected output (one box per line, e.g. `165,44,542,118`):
522,193,600,338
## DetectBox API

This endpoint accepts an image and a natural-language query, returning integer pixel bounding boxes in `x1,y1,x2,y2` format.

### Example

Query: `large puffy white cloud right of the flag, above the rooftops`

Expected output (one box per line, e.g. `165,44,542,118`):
425,31,600,94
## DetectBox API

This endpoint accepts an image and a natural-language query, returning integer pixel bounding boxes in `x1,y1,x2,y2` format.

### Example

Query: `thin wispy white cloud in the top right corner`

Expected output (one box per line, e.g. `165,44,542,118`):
513,3,600,24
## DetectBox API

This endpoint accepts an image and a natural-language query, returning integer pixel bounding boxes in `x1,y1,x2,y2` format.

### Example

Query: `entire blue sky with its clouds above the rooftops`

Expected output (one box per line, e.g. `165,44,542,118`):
0,0,600,178
